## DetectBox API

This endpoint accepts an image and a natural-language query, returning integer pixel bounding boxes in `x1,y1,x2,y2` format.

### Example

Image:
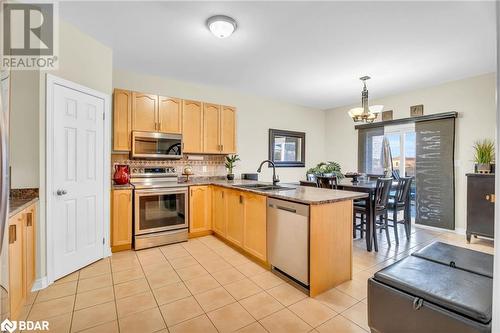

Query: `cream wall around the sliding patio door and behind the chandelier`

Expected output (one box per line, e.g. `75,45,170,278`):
326,73,496,231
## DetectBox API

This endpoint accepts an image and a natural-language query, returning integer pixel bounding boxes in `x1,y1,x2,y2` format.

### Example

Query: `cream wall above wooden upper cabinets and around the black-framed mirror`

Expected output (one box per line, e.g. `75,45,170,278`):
113,70,325,182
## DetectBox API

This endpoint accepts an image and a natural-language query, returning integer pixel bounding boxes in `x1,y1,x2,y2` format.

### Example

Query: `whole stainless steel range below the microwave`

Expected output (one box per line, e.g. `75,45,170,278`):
130,166,189,250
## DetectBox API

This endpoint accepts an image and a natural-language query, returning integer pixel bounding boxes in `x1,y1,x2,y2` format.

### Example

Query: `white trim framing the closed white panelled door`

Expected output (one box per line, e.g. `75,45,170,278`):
45,74,111,285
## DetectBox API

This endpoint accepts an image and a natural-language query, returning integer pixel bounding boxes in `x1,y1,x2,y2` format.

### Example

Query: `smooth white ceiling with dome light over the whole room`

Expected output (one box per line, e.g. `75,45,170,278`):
60,1,496,109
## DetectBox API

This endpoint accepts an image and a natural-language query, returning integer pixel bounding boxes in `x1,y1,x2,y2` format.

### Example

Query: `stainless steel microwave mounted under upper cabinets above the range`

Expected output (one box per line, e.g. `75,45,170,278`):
131,131,182,159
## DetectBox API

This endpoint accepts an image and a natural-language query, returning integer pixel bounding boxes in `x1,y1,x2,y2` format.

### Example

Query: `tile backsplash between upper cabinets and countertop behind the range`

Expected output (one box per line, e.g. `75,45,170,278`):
111,154,226,177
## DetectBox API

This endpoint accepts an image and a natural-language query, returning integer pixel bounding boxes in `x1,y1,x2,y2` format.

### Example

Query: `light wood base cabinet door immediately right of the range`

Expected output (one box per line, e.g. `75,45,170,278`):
189,186,212,233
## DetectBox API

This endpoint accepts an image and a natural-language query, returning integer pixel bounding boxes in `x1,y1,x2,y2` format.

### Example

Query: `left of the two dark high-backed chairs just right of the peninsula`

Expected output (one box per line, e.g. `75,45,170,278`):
353,178,392,251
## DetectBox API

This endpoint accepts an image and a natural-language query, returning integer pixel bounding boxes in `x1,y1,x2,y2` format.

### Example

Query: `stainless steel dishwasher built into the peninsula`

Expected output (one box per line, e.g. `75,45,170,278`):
267,198,309,286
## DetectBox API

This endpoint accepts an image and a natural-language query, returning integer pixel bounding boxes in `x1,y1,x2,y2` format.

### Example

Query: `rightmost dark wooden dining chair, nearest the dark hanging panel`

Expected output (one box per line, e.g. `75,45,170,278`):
388,177,413,245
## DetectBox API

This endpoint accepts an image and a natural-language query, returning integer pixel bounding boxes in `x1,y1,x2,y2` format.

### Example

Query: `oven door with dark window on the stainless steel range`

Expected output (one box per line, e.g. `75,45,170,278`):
134,188,188,235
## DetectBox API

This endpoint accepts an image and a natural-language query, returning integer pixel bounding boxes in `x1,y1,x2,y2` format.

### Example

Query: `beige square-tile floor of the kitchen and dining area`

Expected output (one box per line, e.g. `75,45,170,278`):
25,224,493,333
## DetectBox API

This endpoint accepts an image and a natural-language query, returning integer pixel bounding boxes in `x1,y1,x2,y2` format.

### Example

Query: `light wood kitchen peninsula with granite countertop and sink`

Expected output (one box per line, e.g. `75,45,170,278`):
182,180,367,297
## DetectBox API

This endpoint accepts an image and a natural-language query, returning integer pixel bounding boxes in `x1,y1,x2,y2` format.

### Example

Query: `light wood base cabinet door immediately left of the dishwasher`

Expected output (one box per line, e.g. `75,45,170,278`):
243,192,267,261
